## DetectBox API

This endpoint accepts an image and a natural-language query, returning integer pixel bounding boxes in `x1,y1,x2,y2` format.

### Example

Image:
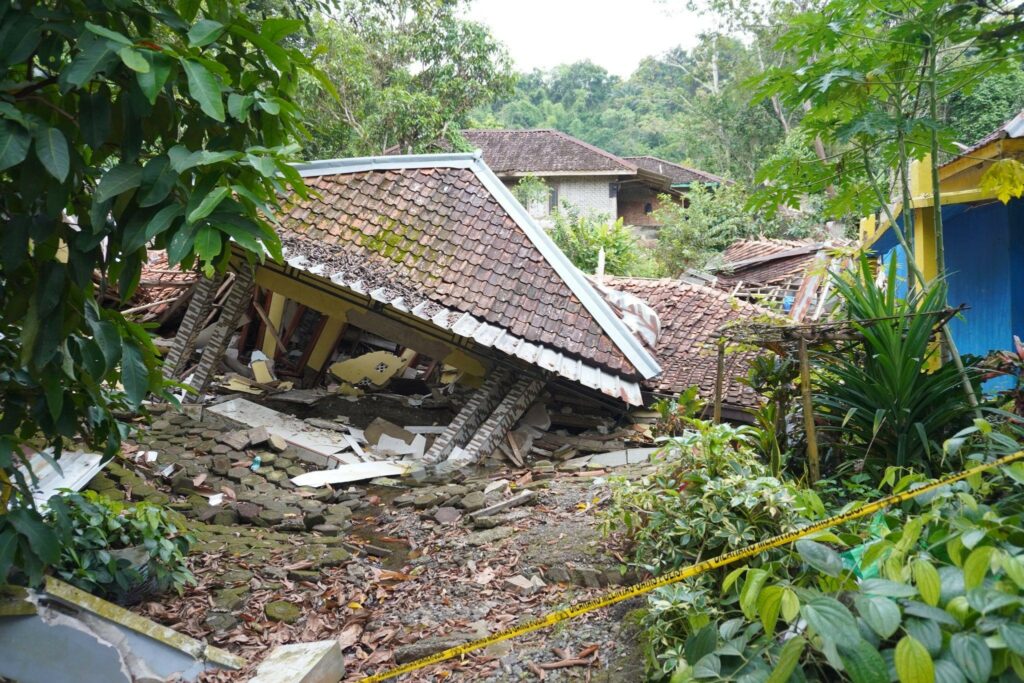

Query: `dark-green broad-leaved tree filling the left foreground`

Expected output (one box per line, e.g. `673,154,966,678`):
0,0,330,582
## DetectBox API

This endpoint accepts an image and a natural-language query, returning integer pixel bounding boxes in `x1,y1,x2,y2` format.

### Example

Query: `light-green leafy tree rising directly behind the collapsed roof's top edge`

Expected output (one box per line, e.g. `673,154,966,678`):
299,0,514,158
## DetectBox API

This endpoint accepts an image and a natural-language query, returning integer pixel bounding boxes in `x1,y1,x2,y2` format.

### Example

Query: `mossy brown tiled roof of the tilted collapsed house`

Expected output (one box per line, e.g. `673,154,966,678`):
281,155,657,389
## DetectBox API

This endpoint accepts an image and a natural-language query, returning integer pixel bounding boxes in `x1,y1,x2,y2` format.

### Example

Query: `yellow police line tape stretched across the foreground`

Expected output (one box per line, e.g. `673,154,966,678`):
361,451,1024,683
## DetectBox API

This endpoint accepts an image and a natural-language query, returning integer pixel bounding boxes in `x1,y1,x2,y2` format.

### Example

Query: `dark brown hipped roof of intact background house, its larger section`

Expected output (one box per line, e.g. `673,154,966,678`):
462,129,637,175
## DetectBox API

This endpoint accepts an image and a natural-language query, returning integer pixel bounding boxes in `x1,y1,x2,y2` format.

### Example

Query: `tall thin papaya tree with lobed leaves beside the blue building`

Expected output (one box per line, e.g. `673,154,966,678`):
759,0,1024,413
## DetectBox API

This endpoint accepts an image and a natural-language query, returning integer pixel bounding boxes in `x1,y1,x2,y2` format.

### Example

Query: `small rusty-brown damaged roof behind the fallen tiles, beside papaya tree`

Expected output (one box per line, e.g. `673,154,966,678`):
717,240,822,287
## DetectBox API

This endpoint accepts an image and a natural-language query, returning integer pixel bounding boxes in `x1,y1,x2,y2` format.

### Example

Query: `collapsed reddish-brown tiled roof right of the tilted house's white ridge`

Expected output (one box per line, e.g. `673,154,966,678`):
604,278,768,408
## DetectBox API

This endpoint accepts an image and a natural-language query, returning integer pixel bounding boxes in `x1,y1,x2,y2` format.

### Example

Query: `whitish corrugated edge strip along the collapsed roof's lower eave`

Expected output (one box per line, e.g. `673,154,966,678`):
285,248,643,405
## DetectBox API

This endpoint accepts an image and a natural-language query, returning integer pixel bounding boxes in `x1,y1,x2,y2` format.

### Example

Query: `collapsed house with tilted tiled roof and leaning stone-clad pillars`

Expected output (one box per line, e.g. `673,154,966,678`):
165,155,660,463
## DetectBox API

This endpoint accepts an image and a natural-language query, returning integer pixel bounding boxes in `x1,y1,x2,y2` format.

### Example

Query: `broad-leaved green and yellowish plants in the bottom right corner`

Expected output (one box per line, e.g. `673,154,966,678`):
671,454,1024,683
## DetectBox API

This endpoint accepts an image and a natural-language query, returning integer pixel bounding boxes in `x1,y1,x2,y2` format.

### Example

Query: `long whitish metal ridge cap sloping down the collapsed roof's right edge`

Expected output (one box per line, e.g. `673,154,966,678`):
472,157,662,379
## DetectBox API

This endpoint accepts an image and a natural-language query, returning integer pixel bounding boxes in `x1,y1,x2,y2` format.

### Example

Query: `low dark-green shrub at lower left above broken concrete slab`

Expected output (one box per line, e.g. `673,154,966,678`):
47,490,196,604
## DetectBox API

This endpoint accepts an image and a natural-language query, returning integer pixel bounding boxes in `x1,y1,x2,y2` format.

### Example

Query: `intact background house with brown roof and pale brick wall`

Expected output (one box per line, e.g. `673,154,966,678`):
452,129,727,239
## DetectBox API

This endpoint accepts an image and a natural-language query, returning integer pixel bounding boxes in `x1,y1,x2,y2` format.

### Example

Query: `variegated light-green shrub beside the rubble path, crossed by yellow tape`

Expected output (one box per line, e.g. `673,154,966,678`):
602,420,821,677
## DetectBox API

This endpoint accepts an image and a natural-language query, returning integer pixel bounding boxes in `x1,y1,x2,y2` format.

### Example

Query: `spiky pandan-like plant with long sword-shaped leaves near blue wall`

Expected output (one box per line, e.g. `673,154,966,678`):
815,258,971,472
